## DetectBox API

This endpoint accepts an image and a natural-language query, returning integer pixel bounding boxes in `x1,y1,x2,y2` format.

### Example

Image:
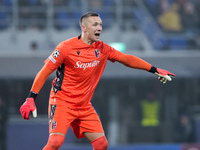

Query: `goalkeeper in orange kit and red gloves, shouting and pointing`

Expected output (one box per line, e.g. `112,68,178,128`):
20,12,175,150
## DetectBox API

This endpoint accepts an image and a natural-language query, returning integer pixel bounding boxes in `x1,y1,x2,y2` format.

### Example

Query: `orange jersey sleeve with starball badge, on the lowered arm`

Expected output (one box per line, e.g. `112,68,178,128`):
44,42,66,70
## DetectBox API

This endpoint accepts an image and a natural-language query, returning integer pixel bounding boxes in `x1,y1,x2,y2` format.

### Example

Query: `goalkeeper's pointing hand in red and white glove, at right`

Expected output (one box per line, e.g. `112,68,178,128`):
154,68,176,84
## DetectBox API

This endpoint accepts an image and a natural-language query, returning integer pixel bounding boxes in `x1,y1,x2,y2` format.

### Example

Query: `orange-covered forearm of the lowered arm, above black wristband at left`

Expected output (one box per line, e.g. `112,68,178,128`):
31,64,54,94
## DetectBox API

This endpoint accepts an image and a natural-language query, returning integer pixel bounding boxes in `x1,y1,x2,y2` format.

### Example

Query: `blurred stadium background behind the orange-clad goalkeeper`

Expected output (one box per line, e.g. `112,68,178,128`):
0,0,200,150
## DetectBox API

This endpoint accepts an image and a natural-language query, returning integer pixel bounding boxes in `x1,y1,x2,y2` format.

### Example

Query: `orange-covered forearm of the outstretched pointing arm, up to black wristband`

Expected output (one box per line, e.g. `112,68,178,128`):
118,53,151,71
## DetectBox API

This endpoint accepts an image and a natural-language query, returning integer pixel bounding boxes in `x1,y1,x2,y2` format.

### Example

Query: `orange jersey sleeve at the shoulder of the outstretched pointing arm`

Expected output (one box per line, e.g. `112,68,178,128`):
105,44,121,62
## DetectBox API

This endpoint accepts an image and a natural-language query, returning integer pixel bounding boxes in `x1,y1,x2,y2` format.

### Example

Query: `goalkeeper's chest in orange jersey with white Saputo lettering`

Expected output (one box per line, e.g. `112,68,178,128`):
62,48,107,81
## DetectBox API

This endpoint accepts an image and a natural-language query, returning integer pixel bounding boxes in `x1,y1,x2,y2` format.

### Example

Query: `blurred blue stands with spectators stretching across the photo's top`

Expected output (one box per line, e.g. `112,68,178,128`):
0,0,200,49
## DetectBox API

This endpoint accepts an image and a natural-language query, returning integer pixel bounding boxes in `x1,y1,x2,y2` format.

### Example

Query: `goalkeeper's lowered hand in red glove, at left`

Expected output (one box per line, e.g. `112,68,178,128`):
20,97,37,120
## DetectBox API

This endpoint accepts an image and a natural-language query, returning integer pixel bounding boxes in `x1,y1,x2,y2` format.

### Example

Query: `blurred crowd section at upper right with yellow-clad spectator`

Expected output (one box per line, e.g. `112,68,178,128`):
144,0,200,50
